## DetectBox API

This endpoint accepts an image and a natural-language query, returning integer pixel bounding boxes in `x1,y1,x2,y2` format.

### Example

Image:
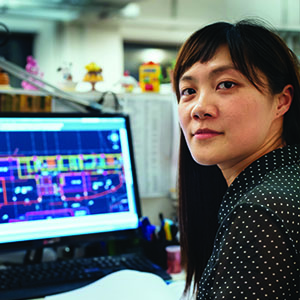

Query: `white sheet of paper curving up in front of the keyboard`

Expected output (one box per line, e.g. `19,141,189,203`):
45,270,183,300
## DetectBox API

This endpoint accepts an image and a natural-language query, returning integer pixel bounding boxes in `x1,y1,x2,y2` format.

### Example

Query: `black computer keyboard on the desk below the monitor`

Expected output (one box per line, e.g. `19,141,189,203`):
0,253,171,300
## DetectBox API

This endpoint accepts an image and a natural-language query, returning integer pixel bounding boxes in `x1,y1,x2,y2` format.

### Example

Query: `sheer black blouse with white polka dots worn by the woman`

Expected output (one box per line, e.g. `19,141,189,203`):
197,146,300,300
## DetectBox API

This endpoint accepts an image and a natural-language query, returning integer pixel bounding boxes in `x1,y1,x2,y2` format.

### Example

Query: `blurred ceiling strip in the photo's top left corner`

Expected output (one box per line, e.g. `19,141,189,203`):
0,0,143,21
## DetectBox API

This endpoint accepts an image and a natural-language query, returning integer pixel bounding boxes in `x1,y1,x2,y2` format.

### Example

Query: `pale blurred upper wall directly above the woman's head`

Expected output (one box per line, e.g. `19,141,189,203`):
121,0,300,47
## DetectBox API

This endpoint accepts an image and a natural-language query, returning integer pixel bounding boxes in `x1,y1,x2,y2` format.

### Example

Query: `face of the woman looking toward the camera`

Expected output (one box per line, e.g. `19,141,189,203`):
178,46,283,180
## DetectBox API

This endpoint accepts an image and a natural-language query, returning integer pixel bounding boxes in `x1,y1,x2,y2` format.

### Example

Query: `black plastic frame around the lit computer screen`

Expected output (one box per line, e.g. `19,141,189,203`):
0,112,142,254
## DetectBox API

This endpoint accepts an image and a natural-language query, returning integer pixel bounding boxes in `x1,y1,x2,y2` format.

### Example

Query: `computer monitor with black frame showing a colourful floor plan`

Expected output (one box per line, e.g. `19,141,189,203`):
0,113,141,250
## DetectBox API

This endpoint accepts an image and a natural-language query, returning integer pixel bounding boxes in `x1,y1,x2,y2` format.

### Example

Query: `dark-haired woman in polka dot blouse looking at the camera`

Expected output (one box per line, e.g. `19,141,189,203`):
173,20,300,299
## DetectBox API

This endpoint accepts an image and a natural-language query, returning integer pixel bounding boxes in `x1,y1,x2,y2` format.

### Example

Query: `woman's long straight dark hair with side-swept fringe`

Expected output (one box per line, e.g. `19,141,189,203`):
173,20,300,291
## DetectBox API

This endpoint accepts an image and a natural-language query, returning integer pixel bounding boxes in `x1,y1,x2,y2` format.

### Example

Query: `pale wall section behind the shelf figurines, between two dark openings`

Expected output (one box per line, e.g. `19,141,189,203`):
52,23,123,84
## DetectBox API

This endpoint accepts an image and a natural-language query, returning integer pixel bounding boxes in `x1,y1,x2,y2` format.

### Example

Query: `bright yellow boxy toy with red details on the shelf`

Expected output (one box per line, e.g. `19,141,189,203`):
139,61,161,92
